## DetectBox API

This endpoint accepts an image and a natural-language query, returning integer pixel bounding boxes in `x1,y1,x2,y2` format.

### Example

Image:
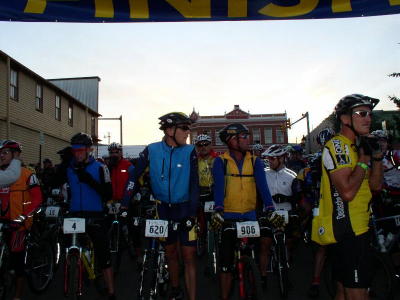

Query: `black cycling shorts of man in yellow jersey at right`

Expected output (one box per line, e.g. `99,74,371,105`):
331,232,374,289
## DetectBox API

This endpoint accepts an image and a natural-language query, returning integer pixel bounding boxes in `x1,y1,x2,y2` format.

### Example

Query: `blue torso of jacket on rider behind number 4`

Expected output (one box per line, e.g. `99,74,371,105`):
67,157,104,212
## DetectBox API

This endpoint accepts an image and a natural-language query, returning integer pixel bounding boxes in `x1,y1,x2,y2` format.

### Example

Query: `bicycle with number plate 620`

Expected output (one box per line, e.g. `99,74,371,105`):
133,207,173,300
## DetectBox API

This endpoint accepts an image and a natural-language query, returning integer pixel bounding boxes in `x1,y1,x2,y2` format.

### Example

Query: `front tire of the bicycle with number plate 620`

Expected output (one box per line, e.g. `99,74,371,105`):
138,251,158,300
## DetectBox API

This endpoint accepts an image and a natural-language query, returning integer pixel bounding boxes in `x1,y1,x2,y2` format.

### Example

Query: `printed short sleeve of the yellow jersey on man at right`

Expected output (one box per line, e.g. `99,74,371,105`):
322,139,352,172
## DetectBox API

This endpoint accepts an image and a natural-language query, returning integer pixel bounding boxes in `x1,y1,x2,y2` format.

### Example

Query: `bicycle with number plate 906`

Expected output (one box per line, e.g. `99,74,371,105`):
219,220,264,300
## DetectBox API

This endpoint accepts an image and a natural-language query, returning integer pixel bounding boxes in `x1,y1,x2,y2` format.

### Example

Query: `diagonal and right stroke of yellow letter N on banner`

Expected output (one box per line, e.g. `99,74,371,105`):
166,0,211,18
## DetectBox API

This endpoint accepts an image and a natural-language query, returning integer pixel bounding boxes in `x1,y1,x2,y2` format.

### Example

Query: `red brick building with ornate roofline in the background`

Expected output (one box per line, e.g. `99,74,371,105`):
190,105,288,152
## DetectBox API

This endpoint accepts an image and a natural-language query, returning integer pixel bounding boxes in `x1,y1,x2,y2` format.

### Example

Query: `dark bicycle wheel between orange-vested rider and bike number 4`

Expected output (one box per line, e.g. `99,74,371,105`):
25,241,55,294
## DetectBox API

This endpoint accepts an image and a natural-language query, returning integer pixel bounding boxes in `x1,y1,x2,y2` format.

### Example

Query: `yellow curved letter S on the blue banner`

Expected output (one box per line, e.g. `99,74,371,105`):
258,0,318,18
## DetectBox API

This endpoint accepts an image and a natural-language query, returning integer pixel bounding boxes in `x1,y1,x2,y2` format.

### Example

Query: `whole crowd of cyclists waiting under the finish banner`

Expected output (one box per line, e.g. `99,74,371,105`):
0,94,400,300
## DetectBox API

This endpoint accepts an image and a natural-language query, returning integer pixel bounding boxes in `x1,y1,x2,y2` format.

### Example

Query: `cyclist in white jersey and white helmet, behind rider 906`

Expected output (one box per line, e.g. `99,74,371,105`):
260,145,297,288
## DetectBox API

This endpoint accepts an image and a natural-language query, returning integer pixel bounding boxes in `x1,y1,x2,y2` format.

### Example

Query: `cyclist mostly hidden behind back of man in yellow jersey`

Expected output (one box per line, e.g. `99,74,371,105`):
297,128,335,298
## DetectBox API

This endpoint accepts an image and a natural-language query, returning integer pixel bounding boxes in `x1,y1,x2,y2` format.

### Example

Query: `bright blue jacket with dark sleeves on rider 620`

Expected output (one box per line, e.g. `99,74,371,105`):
123,141,199,219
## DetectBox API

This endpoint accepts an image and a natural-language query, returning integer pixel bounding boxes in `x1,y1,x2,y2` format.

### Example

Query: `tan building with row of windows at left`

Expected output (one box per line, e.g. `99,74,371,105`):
0,51,100,164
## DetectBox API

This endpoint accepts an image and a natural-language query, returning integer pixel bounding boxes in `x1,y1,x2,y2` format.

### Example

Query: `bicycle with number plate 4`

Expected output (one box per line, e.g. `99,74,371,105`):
63,217,105,300
